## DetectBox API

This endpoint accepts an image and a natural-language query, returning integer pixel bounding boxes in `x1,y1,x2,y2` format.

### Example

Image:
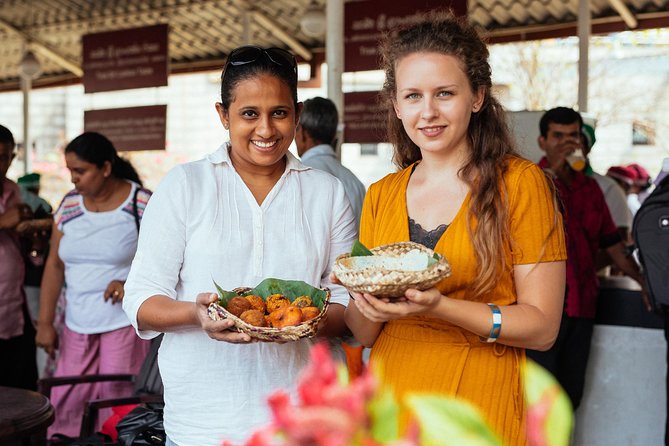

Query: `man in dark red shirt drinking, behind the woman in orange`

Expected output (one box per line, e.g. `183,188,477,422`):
528,107,648,410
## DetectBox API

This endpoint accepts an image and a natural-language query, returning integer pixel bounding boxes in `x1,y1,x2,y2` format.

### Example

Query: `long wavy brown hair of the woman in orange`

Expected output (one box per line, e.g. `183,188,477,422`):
381,10,519,295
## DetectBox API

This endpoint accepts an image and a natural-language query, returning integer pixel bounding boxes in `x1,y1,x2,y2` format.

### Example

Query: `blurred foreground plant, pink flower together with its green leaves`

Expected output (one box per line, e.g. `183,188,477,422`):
223,343,571,446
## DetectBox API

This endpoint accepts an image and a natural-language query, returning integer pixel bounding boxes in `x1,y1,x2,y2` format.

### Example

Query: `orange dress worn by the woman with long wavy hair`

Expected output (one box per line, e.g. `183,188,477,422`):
360,158,567,445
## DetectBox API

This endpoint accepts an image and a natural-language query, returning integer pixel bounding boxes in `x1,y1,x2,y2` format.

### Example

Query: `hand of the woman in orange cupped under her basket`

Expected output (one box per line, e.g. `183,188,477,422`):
351,288,443,322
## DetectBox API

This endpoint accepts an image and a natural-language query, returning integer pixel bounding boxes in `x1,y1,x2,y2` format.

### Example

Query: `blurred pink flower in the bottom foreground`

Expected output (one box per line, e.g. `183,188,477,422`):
231,343,486,446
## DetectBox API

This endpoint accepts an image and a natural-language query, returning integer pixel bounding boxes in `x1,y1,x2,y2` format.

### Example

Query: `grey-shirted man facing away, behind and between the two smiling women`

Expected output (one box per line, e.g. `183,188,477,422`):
295,97,365,226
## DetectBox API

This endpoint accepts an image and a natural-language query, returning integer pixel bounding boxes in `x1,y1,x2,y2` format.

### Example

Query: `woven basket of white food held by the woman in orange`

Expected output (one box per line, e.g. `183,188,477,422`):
333,242,451,297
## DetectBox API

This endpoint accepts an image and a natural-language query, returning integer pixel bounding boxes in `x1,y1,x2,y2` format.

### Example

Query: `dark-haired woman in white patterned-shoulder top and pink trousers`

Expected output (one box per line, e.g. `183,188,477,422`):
36,132,151,436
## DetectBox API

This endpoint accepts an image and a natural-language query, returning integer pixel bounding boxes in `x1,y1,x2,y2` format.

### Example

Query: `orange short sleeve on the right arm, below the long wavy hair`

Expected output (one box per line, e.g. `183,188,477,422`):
506,161,567,264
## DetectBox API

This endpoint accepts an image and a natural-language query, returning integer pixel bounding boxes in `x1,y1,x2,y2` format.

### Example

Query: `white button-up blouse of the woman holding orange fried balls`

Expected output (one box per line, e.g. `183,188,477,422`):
123,145,357,446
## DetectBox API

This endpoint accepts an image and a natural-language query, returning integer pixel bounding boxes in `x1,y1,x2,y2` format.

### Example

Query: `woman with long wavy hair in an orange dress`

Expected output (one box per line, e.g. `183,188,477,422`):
346,12,566,445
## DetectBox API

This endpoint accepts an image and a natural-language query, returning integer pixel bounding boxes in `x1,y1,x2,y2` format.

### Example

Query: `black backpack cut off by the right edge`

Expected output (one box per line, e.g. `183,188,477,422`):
632,176,669,309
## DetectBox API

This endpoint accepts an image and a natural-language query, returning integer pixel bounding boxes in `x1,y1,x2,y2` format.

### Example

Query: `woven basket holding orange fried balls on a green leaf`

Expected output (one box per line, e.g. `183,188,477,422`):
207,287,330,342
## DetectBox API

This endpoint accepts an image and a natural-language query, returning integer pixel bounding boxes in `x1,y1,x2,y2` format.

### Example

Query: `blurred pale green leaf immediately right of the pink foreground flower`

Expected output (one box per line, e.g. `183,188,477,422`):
406,394,502,446
